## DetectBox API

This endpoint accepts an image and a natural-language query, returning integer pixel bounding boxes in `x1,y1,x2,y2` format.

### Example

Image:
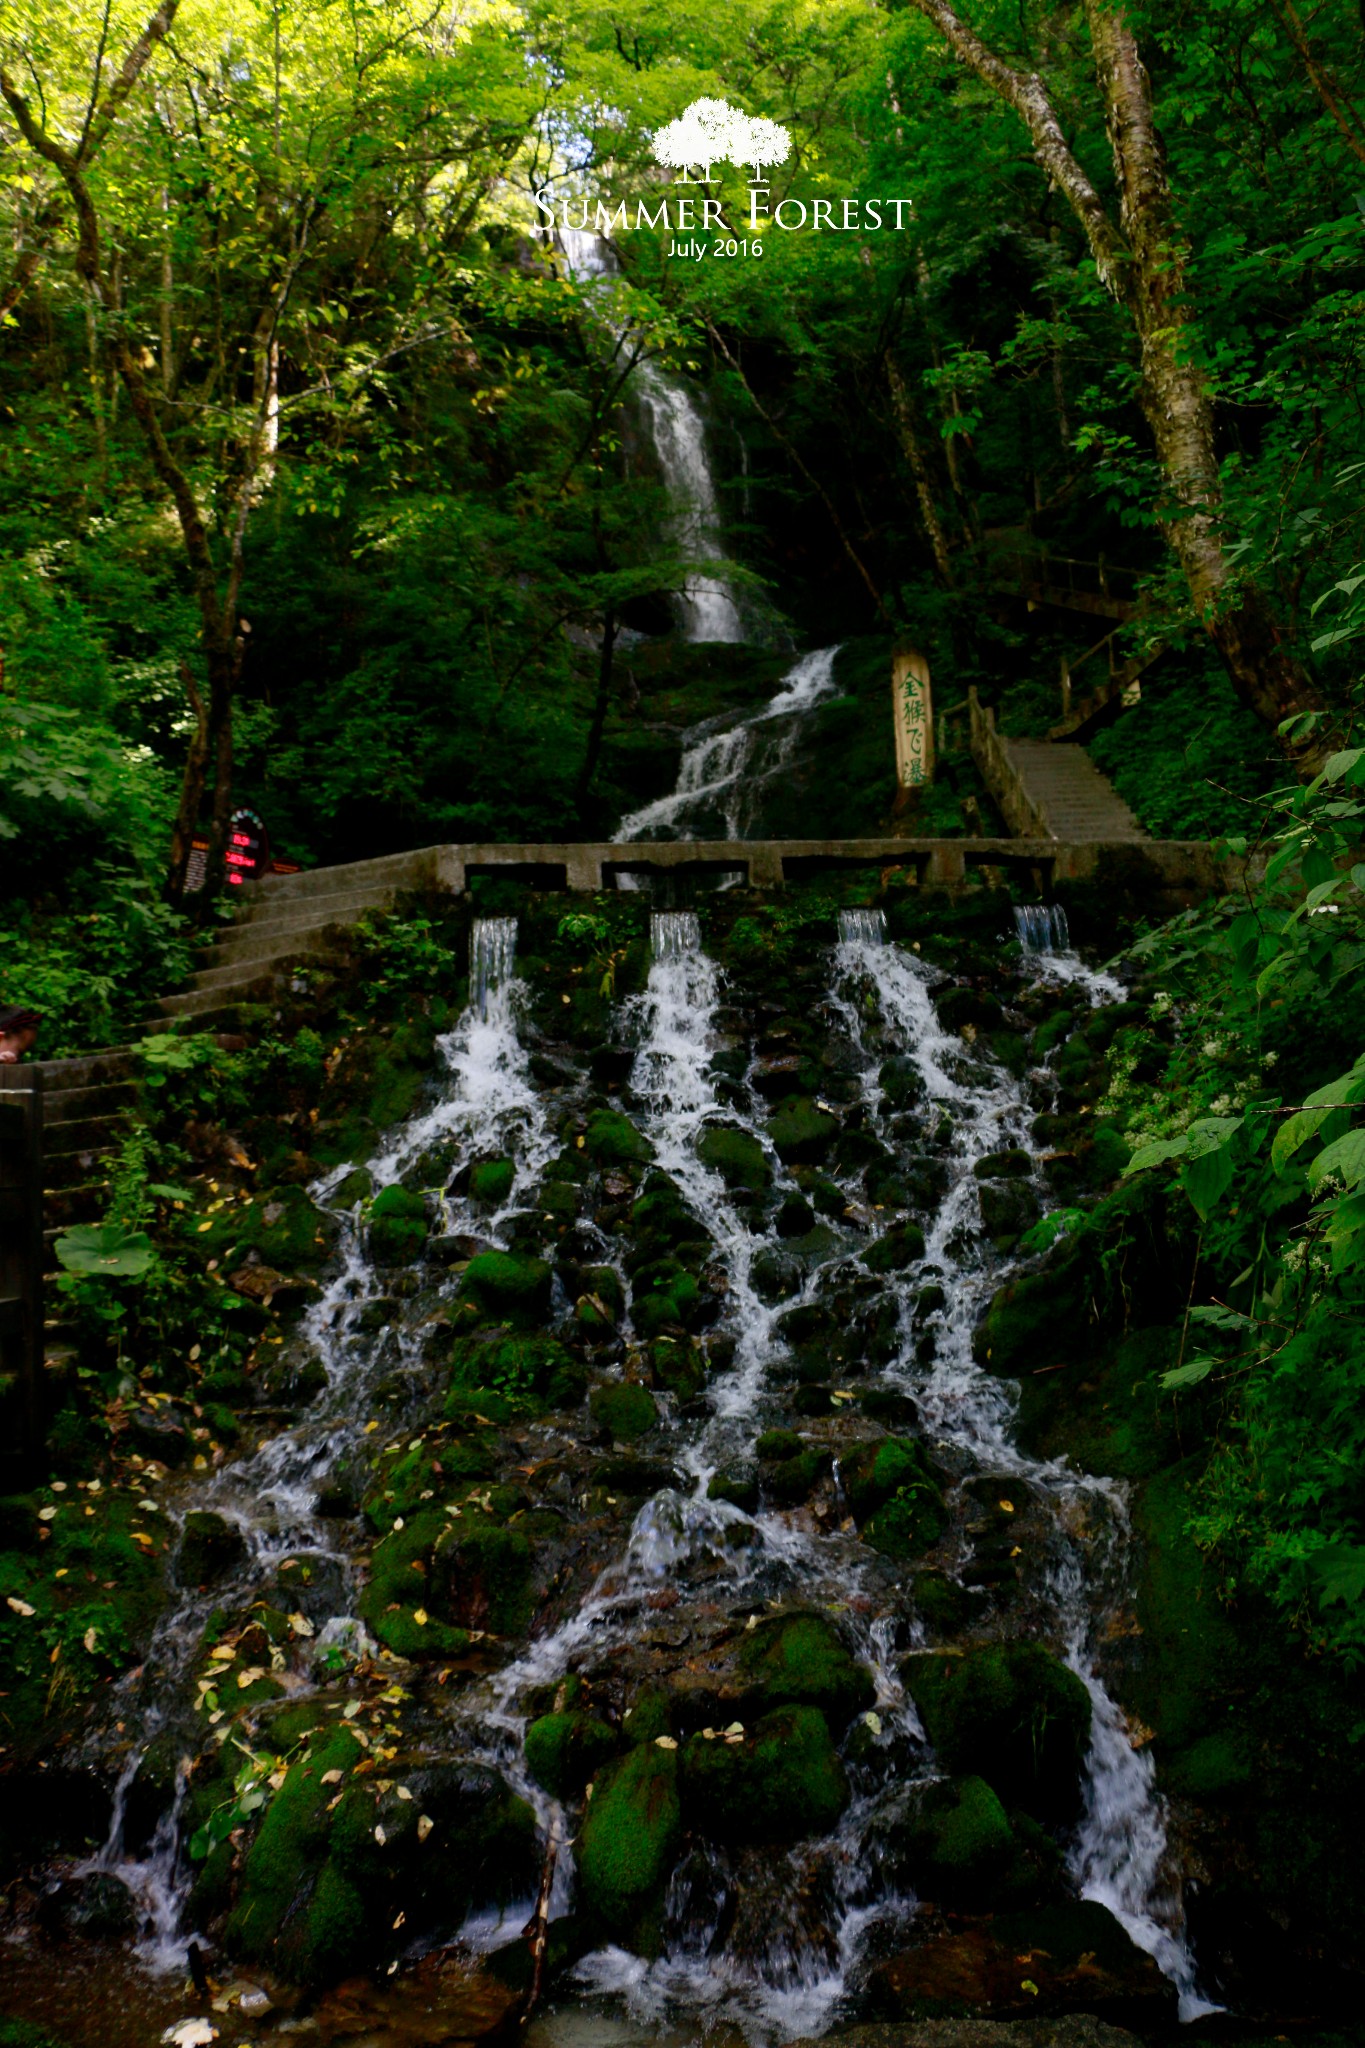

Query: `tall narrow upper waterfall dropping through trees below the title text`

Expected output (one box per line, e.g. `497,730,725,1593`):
559,227,745,641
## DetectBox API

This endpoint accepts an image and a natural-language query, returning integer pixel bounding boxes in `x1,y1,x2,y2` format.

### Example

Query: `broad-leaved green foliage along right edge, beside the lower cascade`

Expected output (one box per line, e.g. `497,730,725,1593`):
1117,748,1365,1665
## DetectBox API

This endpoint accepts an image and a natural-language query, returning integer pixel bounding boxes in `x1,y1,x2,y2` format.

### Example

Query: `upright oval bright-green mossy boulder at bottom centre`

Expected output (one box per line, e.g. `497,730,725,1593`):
577,1743,681,1956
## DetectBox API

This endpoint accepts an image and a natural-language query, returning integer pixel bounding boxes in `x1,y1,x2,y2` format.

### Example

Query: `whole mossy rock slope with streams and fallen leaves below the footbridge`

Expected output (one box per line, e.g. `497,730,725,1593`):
8,891,1309,2042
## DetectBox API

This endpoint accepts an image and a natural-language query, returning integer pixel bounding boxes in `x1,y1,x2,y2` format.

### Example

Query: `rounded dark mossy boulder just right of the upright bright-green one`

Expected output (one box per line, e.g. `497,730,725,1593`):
679,1706,849,1843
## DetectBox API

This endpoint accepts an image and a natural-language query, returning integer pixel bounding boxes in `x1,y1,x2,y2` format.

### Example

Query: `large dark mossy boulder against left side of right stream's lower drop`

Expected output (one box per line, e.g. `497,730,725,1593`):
902,1642,1091,1821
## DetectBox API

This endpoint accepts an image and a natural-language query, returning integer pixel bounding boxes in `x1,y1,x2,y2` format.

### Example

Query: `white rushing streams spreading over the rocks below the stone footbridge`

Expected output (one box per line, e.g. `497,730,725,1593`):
72,909,1209,2044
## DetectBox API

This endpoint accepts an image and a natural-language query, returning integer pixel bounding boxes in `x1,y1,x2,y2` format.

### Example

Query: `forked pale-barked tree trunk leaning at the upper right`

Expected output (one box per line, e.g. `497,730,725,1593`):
911,0,1324,766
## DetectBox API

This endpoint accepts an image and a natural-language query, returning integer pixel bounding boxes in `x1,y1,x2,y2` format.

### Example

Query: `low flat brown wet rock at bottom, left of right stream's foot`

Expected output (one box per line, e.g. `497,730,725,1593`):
870,1901,1175,2040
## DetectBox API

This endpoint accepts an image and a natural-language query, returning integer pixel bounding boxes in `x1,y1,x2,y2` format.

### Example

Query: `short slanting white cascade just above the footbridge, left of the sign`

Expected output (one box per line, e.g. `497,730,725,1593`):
616,645,839,840
